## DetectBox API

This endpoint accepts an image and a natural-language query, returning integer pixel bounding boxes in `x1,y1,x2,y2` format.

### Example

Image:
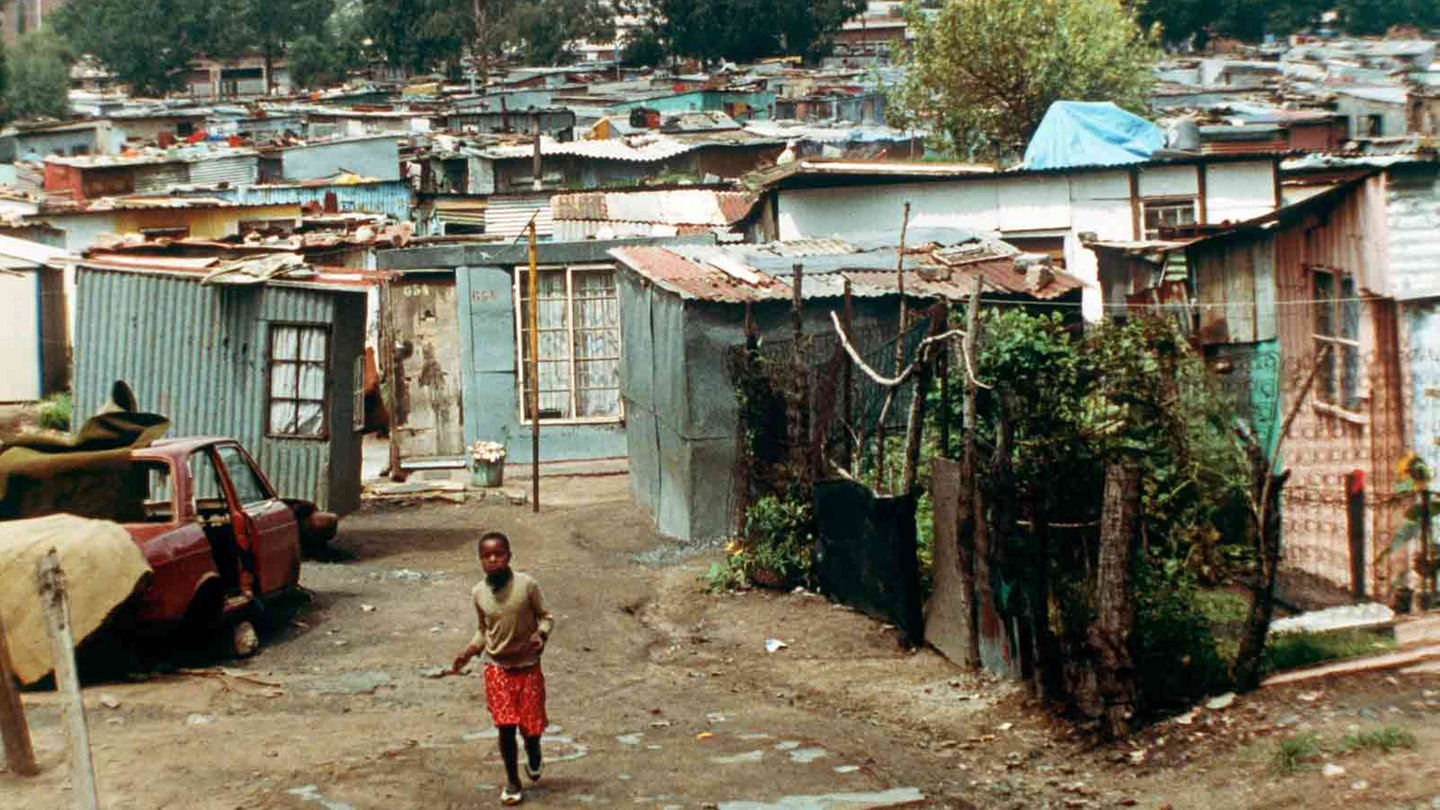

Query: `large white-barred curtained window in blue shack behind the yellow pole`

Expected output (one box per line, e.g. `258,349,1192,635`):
516,265,622,424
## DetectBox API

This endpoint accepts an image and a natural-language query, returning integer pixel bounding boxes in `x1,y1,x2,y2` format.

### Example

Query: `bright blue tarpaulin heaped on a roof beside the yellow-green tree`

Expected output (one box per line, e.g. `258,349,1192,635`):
1024,101,1165,169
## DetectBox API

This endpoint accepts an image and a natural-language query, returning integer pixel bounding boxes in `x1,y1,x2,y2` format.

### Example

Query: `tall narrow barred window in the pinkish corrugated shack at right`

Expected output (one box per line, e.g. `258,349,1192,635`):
1312,268,1361,412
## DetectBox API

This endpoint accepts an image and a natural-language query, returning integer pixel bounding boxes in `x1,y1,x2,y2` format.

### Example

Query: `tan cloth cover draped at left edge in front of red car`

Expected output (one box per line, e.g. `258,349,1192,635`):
0,515,150,683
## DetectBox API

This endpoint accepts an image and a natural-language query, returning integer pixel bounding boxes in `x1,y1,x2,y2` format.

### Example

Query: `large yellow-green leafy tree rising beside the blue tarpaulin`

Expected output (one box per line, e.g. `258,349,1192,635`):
899,0,1158,156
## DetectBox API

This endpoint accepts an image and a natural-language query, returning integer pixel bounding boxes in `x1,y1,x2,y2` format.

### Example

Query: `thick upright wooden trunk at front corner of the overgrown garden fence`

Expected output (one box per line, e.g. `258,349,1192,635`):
1090,461,1140,739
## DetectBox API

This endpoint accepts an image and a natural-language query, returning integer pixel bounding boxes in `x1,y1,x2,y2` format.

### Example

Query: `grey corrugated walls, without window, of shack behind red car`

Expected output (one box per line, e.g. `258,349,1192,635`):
75,268,364,512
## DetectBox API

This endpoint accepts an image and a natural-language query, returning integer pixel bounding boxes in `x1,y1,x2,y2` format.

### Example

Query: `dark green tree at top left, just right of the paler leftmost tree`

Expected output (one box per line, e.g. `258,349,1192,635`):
50,0,214,95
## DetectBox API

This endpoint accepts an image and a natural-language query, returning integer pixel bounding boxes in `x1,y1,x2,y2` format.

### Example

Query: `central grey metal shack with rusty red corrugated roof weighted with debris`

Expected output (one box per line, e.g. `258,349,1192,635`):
611,229,1083,540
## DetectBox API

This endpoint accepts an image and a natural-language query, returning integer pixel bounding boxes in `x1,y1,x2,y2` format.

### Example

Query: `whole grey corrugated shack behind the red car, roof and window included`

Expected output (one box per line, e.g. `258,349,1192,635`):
75,254,370,515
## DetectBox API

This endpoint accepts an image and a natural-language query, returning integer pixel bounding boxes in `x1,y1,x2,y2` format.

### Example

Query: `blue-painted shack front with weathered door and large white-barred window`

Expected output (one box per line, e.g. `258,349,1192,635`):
377,238,713,470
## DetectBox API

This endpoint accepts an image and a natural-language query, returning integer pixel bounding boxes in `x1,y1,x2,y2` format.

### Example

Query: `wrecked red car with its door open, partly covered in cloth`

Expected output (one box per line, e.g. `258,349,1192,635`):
0,435,338,654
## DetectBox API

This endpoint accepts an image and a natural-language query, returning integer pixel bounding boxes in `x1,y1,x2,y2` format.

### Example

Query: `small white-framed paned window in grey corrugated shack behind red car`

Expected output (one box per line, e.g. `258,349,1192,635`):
266,324,330,438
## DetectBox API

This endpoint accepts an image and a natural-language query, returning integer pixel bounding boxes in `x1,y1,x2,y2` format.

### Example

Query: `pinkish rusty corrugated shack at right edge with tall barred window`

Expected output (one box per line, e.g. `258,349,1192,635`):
1094,174,1407,595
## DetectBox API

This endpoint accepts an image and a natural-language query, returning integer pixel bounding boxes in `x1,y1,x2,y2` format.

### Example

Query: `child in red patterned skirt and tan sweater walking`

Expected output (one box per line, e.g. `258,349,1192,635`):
451,532,554,804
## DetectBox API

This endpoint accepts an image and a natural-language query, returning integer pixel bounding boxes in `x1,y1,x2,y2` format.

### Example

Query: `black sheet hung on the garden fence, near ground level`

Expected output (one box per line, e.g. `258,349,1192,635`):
815,481,924,644
